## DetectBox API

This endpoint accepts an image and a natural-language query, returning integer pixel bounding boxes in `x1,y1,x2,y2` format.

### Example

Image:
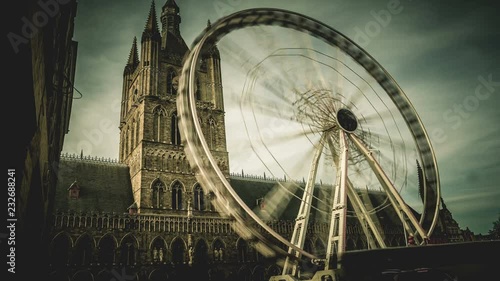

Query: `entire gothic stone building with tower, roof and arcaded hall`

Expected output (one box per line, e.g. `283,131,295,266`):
46,0,460,281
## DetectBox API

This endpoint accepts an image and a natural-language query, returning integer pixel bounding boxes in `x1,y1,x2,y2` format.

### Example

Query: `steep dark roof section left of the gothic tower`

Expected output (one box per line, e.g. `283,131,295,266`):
55,157,134,213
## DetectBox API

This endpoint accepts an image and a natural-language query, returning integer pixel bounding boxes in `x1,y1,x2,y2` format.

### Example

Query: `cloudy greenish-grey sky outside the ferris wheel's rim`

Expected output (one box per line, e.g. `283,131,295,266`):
63,0,500,234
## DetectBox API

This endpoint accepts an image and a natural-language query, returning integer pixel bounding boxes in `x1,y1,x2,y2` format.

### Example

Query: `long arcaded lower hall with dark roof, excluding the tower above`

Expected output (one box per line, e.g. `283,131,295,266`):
49,155,405,281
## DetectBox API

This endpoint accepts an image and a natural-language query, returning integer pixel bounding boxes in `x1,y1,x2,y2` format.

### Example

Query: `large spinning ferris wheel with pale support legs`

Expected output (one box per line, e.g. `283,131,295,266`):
177,8,440,275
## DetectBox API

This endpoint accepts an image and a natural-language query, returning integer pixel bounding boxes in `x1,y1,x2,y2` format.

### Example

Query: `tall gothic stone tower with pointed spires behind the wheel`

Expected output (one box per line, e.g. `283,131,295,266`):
116,1,229,213
